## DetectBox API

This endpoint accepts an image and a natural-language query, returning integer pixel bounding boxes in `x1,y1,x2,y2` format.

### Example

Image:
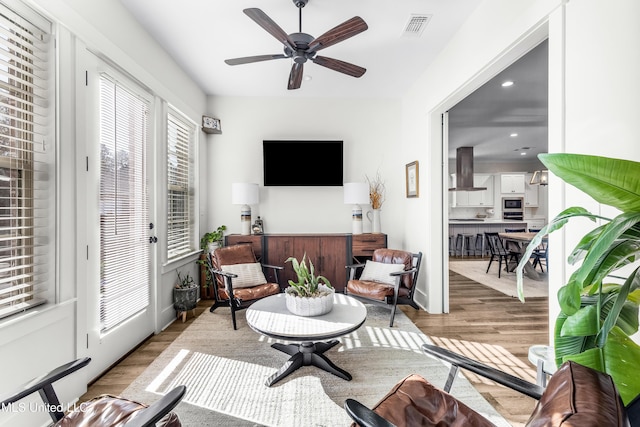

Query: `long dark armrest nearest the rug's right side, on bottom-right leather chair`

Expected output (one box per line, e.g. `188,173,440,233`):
422,344,544,400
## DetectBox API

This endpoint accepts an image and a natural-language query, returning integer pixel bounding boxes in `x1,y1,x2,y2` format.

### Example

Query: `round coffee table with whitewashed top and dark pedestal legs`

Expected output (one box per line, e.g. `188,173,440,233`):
246,294,367,386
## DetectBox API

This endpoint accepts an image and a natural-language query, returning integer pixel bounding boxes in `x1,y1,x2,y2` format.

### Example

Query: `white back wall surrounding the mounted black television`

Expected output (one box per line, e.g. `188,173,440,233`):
202,97,404,250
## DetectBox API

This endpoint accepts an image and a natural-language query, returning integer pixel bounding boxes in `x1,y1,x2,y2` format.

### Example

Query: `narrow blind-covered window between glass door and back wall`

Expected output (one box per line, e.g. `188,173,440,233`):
167,110,197,261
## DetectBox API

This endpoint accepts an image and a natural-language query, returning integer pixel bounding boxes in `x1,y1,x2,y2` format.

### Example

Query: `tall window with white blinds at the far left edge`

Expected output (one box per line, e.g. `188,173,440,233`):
0,5,55,318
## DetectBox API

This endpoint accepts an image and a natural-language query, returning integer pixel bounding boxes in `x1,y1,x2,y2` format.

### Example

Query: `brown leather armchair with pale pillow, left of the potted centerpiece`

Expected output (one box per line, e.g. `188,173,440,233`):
207,244,284,329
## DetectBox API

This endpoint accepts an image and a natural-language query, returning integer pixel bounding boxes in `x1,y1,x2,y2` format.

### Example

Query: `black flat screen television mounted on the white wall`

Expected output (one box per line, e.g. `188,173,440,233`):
262,141,343,187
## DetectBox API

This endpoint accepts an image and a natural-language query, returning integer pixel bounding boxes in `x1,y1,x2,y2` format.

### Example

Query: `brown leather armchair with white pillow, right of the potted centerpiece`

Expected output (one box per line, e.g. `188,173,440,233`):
344,249,422,327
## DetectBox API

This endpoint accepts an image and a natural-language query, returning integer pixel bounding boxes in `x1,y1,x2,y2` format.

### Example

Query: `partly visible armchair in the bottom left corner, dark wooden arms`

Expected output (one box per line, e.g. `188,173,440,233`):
0,357,187,427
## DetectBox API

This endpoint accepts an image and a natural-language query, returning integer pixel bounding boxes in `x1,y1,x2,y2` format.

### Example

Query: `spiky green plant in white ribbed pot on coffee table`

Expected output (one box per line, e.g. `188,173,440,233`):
285,253,335,316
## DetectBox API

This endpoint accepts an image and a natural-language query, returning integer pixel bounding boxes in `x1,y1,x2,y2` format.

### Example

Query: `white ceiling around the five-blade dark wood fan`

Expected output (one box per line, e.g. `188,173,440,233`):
120,0,480,98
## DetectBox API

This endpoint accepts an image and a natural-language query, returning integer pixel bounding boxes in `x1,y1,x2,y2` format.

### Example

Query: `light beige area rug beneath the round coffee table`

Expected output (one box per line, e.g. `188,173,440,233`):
123,305,509,427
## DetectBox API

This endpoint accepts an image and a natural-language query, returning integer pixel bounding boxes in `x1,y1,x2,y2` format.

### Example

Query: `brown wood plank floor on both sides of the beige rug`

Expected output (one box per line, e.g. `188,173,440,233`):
81,272,548,426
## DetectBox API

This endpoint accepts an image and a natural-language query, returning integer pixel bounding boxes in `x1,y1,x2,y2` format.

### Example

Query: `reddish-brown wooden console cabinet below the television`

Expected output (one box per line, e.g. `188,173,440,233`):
225,233,387,292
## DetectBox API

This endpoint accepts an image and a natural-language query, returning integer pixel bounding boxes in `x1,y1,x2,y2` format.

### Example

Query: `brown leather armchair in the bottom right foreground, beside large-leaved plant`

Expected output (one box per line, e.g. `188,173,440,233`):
345,344,640,427
